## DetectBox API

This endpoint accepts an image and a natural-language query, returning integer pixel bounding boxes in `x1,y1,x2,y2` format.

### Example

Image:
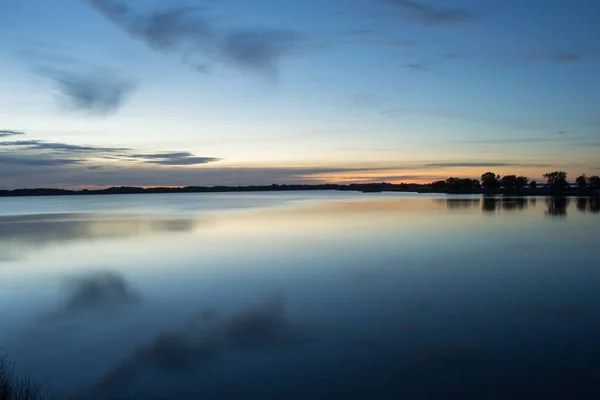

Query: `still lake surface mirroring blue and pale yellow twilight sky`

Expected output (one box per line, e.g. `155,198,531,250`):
0,192,600,399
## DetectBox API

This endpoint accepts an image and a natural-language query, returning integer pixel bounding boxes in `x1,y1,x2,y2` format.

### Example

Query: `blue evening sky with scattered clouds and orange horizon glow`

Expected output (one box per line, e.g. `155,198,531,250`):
0,0,600,188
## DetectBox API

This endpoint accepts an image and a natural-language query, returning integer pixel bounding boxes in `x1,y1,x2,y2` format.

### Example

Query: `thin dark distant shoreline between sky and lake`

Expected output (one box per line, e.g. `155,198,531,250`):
0,183,600,197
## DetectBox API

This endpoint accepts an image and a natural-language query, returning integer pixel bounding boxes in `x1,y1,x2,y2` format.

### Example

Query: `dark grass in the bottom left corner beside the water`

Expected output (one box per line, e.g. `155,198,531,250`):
0,356,58,400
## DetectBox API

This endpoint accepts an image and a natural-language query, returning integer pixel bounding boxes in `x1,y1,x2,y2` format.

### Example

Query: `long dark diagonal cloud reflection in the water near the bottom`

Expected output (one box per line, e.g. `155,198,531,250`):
74,295,309,399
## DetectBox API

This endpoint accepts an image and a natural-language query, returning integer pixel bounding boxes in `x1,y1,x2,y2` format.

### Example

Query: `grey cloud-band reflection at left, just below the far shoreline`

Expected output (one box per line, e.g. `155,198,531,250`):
0,213,199,261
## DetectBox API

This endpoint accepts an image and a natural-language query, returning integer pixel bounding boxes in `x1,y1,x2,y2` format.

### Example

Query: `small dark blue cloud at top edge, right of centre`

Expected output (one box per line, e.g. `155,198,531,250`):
383,0,476,26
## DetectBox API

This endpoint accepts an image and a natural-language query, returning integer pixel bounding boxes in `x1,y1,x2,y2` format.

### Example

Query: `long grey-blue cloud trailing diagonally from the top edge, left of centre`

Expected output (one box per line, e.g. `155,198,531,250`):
86,0,303,76
